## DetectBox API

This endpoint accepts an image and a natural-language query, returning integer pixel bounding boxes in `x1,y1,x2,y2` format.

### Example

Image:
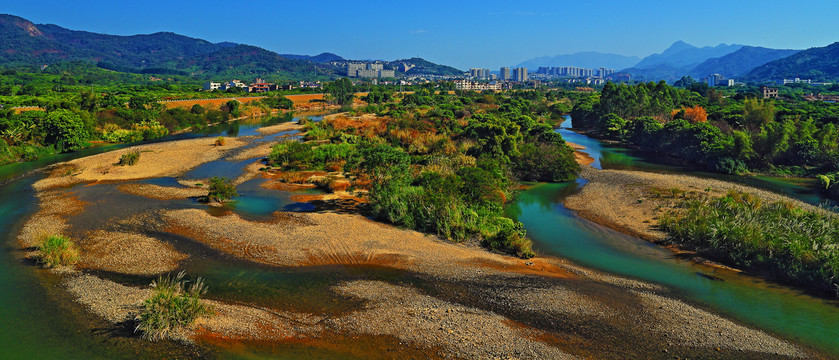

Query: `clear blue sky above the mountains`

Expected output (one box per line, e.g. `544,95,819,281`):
0,0,839,69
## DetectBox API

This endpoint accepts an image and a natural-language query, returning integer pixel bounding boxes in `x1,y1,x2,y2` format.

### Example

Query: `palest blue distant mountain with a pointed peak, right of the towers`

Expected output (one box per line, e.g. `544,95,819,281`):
633,41,743,69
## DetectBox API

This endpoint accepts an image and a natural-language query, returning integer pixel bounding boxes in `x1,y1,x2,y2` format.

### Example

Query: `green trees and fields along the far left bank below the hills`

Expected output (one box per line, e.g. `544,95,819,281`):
0,62,306,164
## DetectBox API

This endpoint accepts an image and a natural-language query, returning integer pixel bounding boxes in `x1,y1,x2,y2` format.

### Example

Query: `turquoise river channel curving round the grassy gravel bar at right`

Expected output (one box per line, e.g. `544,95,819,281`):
508,117,839,355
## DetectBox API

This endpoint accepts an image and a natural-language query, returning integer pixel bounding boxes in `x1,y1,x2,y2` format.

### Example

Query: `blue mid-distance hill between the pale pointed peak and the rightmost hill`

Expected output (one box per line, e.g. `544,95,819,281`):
688,46,800,79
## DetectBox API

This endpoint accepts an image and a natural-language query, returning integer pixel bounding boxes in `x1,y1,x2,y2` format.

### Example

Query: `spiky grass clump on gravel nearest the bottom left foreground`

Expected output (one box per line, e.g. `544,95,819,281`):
134,271,213,341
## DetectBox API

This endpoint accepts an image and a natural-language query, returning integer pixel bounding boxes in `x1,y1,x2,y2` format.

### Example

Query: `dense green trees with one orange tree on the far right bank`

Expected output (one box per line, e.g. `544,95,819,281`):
571,82,839,199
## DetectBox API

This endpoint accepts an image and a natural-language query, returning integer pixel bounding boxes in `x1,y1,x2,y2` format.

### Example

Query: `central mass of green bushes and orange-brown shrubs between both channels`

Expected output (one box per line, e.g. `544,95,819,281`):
268,90,579,258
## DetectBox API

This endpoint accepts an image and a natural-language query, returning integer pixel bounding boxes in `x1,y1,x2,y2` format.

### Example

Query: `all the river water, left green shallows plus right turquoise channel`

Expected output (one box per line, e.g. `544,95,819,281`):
0,113,839,359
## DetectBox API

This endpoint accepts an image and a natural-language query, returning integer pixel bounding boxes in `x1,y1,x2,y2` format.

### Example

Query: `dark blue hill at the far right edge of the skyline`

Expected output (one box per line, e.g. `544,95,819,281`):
745,42,839,81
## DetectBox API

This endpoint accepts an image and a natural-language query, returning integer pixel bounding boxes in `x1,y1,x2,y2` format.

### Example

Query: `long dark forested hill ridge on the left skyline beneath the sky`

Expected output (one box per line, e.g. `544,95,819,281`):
0,14,336,79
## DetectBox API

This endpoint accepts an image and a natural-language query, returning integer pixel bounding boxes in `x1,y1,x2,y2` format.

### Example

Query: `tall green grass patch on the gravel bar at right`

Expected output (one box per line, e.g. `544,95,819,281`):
661,191,839,296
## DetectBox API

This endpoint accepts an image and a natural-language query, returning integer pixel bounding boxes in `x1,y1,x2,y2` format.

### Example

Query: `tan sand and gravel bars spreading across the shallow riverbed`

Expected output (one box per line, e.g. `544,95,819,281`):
13,122,819,359
